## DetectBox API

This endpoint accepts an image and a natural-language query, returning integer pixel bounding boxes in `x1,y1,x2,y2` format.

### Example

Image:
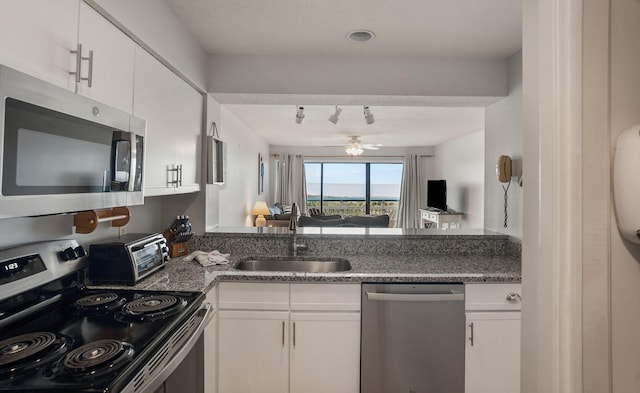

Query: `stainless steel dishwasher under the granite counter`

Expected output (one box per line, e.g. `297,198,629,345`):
360,284,465,393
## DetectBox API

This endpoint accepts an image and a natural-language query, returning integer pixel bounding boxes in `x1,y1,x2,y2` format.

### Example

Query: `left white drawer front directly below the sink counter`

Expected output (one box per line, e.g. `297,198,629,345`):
218,282,289,310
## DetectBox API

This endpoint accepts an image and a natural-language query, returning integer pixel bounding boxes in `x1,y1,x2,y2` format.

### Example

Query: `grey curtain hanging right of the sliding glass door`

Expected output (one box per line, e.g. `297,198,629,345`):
396,154,423,228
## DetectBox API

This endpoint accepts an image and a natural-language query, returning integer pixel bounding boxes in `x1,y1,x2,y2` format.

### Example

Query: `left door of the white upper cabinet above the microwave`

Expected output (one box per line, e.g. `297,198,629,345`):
0,0,79,91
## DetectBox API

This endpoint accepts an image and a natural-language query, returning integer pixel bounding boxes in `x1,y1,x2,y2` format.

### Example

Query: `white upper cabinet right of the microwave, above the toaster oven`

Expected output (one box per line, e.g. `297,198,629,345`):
133,47,203,196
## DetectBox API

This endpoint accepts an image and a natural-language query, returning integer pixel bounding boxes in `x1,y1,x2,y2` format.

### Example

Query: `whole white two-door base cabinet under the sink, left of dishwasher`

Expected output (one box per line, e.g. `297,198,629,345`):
218,283,360,393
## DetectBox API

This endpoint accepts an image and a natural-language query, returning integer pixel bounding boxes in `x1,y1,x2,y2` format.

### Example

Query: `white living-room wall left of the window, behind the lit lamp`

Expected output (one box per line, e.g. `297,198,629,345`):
215,106,270,227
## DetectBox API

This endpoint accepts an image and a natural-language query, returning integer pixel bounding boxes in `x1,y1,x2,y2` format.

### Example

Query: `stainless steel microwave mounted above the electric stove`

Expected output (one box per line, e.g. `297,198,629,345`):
0,65,146,218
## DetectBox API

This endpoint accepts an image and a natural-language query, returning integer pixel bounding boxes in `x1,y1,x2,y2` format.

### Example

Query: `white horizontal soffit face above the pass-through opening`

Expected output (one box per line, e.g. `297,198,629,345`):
208,56,507,98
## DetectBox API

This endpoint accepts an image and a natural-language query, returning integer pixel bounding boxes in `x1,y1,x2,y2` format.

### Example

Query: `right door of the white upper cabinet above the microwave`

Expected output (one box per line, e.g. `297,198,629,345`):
77,2,136,113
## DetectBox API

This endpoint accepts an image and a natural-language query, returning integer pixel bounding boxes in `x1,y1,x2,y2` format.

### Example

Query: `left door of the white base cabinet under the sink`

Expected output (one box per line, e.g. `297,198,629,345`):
218,310,289,393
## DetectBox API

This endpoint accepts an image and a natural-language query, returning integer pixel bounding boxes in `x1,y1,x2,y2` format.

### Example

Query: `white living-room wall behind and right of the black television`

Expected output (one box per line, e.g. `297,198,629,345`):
425,131,485,228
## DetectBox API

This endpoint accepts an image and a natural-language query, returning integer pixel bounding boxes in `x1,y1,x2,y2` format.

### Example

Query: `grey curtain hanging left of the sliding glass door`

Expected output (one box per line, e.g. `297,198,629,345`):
274,154,307,214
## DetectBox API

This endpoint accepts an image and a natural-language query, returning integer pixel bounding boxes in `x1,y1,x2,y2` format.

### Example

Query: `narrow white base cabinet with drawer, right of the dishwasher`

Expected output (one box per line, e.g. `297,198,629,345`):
465,284,521,393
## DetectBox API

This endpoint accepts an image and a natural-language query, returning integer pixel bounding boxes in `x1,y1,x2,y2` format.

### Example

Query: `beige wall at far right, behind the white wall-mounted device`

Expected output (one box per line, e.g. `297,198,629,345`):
608,0,640,393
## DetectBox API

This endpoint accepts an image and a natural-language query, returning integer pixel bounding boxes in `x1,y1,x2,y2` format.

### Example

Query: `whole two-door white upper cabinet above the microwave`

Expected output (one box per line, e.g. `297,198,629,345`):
0,0,135,113
